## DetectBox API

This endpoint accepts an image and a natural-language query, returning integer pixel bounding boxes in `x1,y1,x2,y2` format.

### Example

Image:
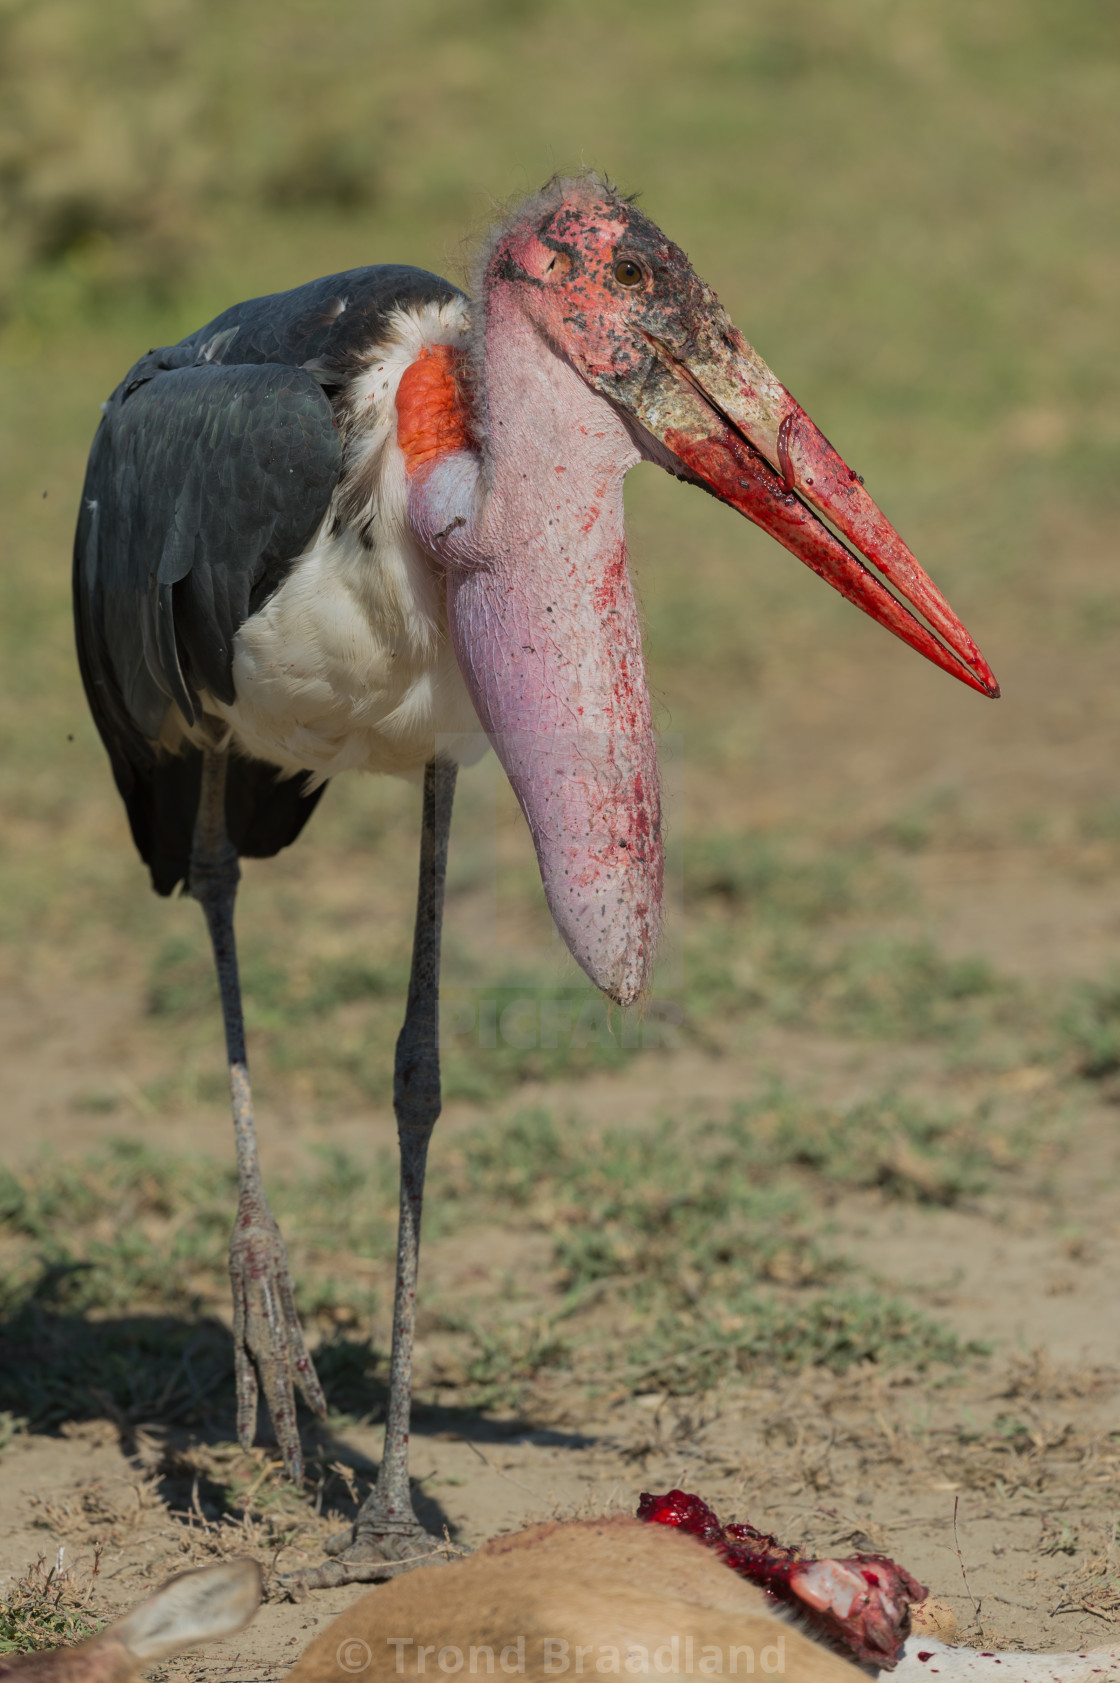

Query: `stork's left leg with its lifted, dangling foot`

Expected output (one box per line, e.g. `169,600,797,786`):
190,749,327,1483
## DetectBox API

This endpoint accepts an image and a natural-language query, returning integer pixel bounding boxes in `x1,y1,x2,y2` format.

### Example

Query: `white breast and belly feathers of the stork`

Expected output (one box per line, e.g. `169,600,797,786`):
194,298,482,788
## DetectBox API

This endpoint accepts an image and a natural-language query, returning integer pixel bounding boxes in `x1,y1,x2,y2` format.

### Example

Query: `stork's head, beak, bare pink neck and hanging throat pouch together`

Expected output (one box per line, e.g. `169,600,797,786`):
424,177,999,1003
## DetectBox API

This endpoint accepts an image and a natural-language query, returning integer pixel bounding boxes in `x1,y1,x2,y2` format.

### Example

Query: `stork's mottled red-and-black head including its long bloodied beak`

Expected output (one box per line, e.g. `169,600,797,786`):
485,175,999,697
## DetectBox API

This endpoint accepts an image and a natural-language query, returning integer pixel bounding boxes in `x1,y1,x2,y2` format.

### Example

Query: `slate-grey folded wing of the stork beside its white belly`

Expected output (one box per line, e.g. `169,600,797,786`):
96,364,342,716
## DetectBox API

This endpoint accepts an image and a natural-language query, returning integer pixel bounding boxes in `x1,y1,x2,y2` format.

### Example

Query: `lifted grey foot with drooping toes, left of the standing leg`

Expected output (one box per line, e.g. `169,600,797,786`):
229,1188,327,1484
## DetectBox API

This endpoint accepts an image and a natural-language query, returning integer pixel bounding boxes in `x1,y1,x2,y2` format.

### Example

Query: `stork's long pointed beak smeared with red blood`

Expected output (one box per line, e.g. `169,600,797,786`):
633,321,999,697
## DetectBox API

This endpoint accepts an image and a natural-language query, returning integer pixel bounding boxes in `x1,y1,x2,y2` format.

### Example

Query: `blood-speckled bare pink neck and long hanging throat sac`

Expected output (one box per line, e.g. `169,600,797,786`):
431,283,662,1005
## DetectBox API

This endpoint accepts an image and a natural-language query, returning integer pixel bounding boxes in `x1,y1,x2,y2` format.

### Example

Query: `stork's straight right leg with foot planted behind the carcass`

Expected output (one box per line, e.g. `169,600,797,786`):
285,759,458,1590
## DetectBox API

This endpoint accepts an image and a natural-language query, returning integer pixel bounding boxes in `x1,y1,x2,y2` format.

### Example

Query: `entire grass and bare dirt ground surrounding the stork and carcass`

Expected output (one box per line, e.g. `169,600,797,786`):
0,0,1120,1680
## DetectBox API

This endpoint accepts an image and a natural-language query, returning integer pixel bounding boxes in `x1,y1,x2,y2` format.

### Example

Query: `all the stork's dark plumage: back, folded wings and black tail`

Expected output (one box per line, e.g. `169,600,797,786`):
74,266,456,894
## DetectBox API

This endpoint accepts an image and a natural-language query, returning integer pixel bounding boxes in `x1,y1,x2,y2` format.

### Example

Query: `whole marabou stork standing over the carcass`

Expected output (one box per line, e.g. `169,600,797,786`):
74,175,999,1582
